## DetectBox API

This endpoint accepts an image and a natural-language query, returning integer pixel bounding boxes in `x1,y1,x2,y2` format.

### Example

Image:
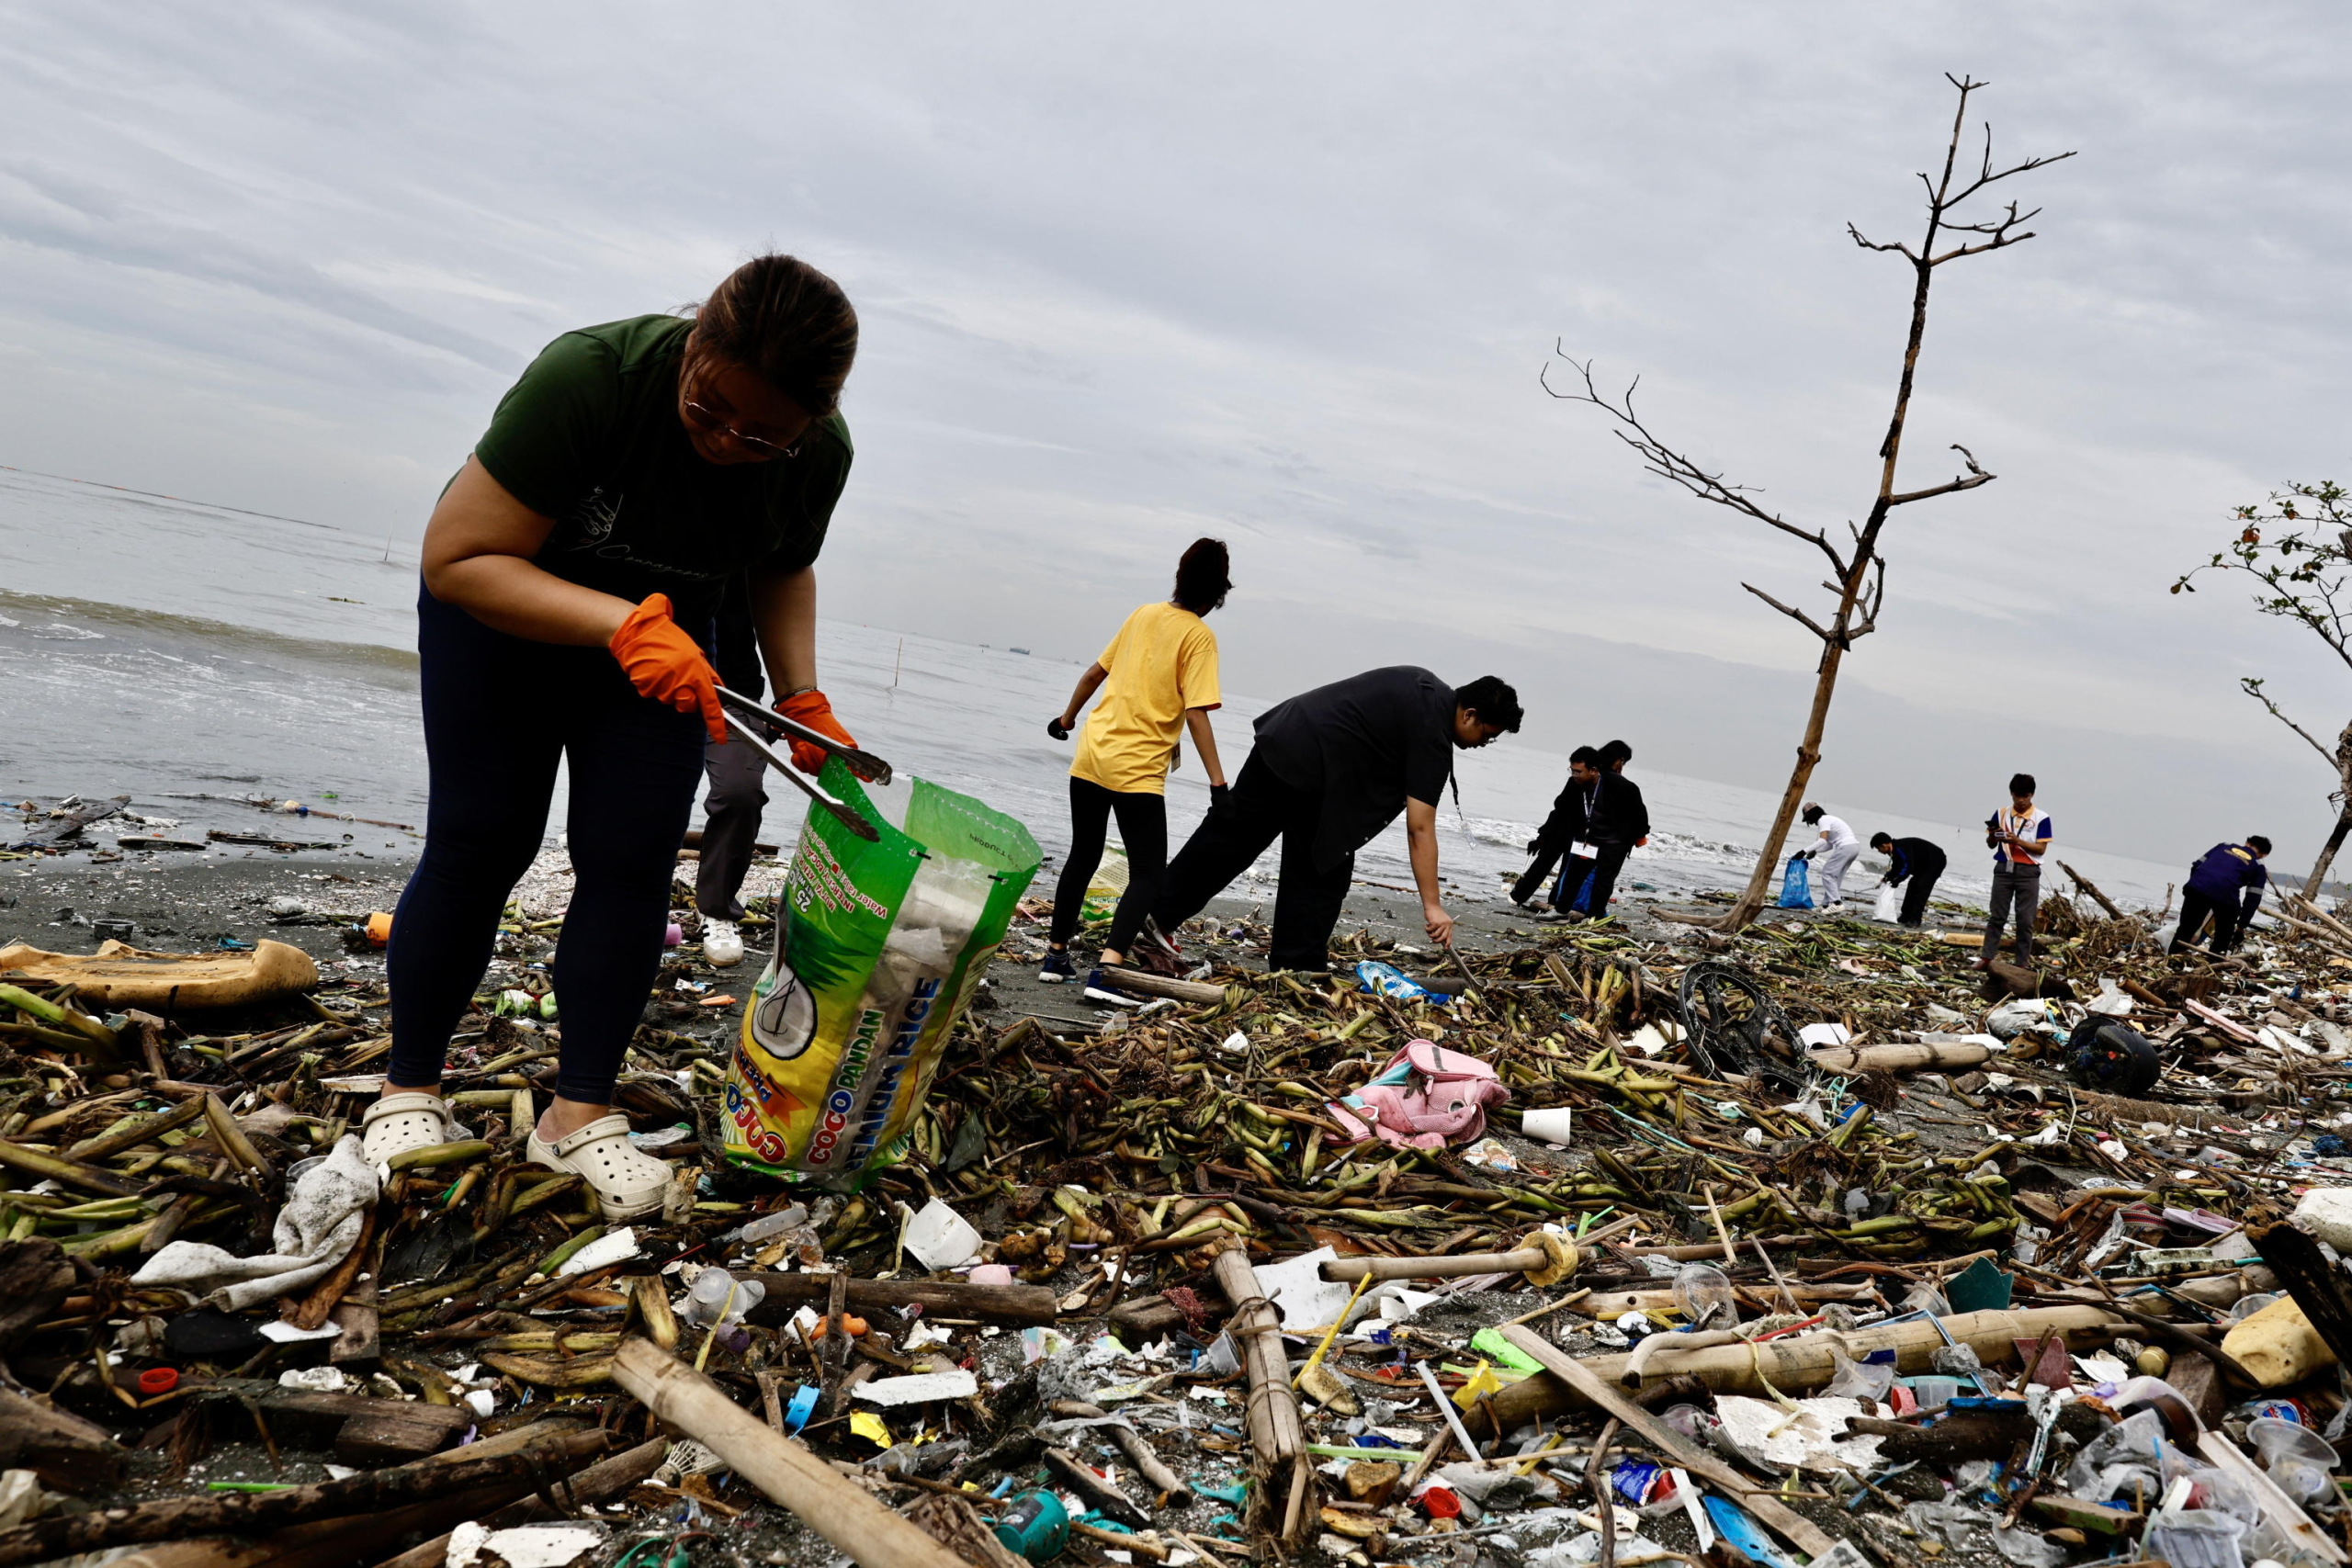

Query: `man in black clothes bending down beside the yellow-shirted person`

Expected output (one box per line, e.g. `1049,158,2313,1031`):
1152,665,1521,968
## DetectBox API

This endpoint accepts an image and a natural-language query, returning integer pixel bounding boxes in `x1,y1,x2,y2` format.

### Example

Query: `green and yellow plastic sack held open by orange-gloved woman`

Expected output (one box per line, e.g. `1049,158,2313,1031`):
727,757,1042,1187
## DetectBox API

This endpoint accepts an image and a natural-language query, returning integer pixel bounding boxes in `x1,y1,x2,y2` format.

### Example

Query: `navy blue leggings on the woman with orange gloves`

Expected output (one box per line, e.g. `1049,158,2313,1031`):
386,592,703,1105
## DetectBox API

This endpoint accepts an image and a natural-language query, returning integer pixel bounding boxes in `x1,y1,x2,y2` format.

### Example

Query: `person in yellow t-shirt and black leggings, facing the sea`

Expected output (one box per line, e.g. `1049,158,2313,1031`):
1037,538,1232,1004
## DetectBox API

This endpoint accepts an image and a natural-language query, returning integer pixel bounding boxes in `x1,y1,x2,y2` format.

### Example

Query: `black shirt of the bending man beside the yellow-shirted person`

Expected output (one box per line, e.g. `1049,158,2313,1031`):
1256,665,1453,867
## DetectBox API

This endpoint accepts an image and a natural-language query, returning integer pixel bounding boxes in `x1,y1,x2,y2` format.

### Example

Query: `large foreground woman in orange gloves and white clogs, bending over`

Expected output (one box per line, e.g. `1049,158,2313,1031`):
362,256,858,1220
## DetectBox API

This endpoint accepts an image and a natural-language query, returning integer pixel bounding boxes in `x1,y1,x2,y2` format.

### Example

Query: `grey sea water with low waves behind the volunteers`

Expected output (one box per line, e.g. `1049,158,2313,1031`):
0,468,2183,908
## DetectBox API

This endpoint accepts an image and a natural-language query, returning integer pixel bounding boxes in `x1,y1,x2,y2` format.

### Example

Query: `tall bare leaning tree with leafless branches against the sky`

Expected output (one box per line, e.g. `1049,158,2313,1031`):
1541,75,2072,931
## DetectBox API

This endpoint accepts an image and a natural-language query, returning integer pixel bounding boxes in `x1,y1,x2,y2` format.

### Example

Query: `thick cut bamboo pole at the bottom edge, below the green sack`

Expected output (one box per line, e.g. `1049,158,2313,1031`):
612,1340,965,1568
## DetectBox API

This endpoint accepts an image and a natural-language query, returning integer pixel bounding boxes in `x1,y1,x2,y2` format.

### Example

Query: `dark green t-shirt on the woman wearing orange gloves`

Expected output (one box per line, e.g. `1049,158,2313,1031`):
473,315,852,637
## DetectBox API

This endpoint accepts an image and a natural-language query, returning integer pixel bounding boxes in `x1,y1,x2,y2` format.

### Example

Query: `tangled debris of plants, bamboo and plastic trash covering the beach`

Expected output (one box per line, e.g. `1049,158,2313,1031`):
0,879,2352,1568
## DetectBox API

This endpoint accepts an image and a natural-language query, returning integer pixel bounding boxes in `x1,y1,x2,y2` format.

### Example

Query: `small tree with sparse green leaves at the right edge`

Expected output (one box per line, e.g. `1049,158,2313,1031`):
2171,479,2352,898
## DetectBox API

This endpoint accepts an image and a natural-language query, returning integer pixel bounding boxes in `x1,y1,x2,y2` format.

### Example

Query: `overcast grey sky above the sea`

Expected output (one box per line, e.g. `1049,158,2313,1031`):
0,0,2352,863
